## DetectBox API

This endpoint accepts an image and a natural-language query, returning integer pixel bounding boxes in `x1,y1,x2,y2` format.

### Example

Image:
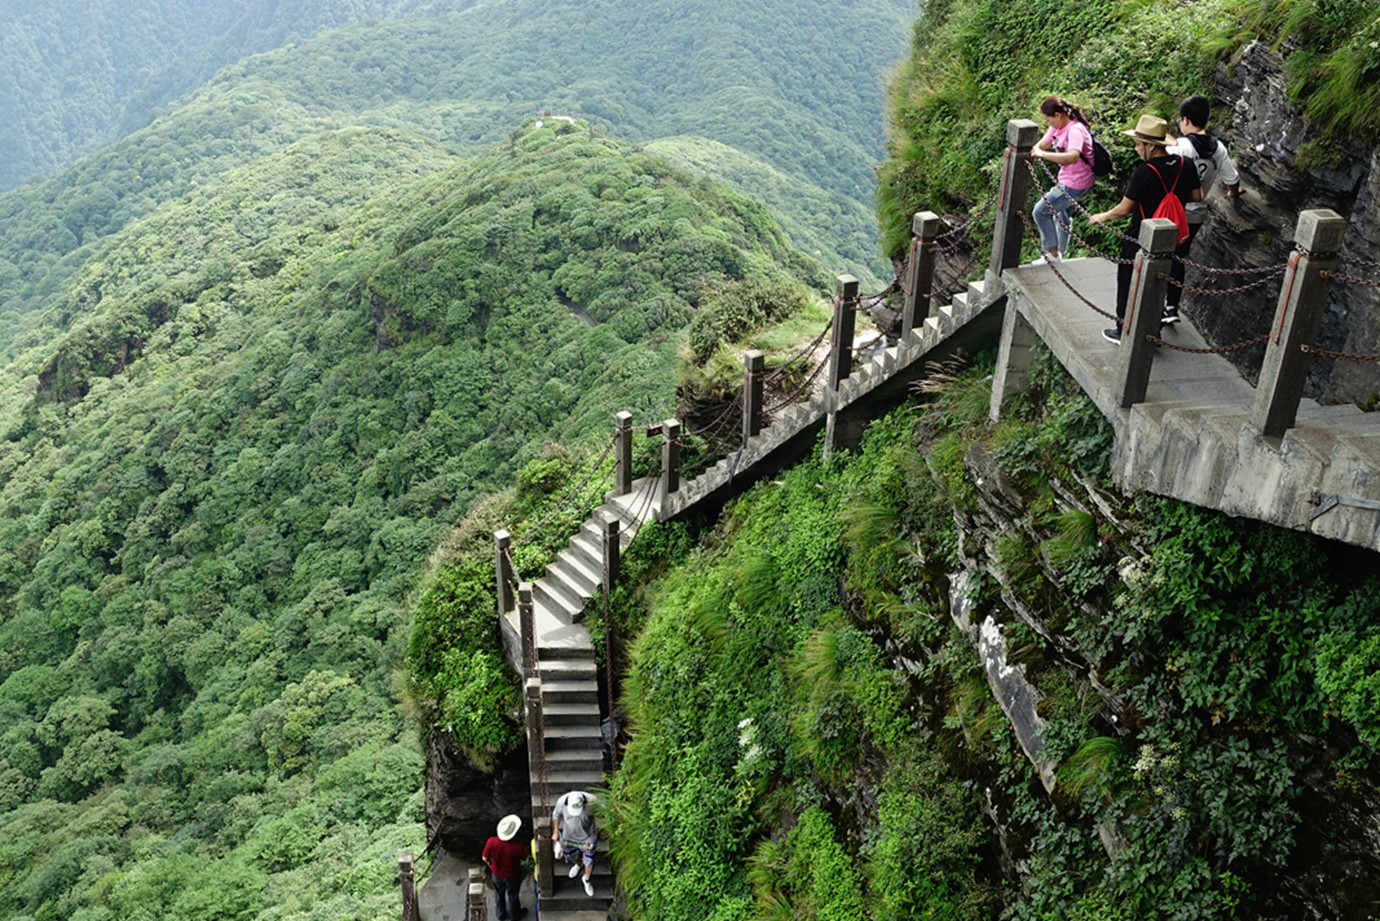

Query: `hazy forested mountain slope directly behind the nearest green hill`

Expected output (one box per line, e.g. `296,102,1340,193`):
0,0,909,313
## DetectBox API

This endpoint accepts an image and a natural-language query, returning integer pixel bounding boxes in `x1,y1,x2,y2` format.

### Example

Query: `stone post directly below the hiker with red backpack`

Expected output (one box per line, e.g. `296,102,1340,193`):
1116,218,1179,409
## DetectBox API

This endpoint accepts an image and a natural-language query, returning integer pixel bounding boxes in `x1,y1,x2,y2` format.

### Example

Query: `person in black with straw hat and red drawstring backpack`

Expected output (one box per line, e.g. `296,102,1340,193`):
1089,115,1203,344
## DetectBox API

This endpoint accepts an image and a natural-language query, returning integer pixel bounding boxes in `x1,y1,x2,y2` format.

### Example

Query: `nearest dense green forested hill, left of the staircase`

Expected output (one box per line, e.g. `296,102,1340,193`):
0,122,821,920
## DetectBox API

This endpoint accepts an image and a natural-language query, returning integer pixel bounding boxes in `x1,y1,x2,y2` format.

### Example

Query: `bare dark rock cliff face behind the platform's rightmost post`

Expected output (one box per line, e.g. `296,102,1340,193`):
1184,41,1380,403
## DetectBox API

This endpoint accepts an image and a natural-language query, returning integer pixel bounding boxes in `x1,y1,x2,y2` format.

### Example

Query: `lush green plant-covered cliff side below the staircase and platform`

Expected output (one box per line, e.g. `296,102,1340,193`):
613,347,1380,921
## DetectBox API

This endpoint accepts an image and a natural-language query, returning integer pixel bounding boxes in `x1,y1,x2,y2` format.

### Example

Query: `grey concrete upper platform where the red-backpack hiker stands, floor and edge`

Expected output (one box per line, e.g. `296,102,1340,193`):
1002,260,1380,550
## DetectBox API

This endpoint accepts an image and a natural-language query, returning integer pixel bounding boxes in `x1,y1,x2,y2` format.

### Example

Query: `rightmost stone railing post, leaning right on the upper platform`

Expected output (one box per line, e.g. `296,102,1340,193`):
1250,209,1347,438
